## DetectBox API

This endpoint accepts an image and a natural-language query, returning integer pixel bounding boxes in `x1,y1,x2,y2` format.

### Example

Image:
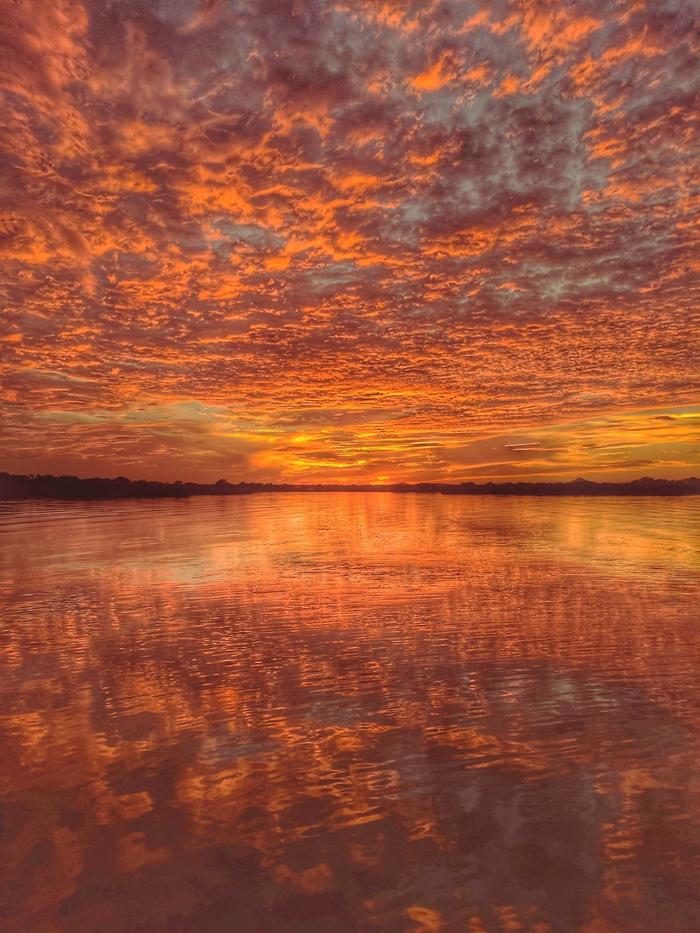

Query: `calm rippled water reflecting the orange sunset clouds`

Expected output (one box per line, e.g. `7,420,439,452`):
0,494,700,933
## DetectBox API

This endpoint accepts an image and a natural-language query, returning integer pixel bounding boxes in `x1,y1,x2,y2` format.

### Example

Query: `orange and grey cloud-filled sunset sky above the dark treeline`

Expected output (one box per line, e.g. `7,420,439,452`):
0,0,700,483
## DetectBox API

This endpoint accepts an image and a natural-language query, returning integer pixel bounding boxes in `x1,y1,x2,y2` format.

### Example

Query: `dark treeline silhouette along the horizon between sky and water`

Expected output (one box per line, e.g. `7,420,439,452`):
0,473,700,499
